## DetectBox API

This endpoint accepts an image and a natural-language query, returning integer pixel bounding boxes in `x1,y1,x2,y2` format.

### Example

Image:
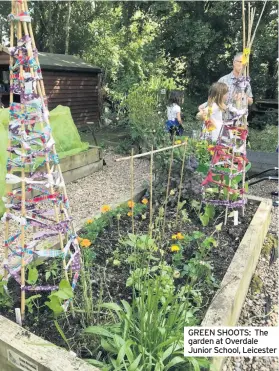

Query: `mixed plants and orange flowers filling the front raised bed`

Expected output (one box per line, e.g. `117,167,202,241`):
0,138,257,371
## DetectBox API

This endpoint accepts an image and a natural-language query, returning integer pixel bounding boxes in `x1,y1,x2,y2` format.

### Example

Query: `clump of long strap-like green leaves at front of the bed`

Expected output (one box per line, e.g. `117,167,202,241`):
85,281,208,371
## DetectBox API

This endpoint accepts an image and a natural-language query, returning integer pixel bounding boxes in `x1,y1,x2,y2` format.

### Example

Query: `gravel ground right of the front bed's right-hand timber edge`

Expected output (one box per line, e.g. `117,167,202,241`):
222,181,279,371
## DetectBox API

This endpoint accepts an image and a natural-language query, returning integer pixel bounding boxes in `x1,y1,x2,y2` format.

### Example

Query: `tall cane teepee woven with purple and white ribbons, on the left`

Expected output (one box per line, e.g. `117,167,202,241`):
2,0,80,317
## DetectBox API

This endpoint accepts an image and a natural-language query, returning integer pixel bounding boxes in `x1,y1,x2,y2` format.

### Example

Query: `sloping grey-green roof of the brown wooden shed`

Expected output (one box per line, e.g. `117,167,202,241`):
0,44,101,73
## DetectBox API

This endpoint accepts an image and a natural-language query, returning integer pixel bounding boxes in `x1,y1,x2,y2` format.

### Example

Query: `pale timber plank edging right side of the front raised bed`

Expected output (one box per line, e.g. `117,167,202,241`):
201,196,272,371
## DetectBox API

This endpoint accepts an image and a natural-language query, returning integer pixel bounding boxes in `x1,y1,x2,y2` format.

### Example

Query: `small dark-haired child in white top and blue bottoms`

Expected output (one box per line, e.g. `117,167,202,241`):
166,91,184,139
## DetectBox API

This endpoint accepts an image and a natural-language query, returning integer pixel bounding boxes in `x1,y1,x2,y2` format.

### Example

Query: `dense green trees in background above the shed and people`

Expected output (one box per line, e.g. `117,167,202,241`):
0,0,278,104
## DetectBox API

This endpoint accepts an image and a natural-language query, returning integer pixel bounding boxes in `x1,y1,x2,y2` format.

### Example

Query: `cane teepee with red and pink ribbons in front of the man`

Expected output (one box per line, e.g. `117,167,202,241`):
202,0,266,224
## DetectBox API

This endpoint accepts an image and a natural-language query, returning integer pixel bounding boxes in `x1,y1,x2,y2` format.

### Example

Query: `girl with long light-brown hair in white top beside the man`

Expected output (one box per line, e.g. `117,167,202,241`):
197,82,229,142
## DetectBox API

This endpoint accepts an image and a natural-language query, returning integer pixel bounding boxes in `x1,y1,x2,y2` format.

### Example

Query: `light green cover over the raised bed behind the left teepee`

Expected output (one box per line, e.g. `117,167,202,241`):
0,105,89,215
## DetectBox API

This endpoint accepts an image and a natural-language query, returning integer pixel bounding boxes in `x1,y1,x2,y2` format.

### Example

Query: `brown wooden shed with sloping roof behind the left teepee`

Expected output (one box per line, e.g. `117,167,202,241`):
0,46,101,126
